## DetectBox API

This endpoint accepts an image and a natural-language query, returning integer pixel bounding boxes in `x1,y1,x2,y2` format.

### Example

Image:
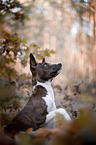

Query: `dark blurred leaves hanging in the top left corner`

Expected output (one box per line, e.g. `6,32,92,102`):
0,0,32,24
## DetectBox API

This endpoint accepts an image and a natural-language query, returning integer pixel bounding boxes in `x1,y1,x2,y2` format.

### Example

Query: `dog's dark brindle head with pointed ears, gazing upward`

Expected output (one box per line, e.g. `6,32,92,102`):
30,53,62,85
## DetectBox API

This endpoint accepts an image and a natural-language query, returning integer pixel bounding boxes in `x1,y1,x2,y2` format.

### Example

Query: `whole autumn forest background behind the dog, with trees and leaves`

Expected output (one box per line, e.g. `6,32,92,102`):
0,0,96,144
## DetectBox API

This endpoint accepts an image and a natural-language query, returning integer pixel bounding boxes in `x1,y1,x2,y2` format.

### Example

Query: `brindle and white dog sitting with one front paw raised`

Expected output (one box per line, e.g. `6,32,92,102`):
4,53,71,135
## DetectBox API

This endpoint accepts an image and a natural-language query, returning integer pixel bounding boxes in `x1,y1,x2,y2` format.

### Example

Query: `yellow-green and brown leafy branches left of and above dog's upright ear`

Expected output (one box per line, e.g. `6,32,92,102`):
0,34,54,82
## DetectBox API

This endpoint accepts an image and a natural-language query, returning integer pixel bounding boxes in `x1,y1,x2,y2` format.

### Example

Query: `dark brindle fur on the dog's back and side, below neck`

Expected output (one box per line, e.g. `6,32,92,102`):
4,86,48,134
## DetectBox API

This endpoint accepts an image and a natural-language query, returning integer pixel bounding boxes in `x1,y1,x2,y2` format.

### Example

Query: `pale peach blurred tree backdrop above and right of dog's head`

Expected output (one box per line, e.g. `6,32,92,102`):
16,0,96,87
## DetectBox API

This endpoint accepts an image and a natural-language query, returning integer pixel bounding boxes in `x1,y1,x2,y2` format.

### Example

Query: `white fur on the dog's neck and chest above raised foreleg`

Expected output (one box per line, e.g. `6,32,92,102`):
36,81,56,113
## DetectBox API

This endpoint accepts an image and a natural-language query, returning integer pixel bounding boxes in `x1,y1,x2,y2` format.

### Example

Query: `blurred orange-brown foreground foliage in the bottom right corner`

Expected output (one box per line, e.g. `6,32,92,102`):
36,109,96,145
